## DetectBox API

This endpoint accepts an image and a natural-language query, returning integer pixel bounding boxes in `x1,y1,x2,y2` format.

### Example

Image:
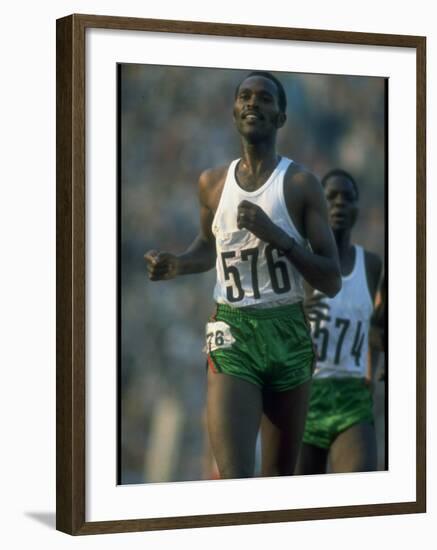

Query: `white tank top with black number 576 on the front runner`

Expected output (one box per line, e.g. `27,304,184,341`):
212,157,306,307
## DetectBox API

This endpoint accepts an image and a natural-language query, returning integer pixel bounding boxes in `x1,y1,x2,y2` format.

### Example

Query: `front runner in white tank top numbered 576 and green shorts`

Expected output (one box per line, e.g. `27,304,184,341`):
145,72,341,484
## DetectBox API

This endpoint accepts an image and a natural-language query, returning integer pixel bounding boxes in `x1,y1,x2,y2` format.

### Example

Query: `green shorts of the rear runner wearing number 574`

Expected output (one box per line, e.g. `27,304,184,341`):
303,377,373,449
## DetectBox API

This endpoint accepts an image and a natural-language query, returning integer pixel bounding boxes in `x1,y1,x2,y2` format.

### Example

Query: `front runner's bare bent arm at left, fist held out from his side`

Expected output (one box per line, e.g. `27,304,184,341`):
144,170,216,281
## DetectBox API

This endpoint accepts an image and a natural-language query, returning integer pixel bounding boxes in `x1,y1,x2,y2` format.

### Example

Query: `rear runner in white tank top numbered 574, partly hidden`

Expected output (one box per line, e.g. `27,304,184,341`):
297,170,381,474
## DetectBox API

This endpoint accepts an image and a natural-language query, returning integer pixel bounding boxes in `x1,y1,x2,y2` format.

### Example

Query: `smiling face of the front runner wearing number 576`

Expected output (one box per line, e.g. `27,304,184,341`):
234,76,285,141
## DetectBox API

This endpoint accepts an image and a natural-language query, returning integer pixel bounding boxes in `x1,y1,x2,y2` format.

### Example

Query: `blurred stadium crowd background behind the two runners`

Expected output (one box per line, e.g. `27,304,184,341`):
119,64,385,483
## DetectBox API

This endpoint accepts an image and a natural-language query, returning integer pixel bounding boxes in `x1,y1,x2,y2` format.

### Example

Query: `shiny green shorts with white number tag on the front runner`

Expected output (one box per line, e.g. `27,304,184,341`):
205,302,314,391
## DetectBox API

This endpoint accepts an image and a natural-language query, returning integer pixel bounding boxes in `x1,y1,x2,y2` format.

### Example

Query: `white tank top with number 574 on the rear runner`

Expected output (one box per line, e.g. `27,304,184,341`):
311,246,373,379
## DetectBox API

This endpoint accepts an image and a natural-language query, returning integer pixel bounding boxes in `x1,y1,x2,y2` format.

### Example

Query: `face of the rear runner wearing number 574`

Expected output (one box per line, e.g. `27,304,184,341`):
325,176,358,231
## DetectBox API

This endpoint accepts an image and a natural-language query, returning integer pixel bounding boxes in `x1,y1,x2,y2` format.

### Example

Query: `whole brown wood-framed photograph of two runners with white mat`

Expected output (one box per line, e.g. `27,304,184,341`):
56,15,426,535
